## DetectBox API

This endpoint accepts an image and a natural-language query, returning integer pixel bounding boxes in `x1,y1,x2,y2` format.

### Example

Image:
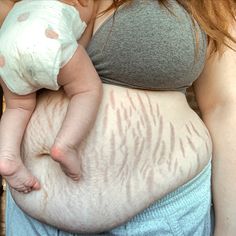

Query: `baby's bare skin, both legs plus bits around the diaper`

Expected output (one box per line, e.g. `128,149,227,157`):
0,1,102,193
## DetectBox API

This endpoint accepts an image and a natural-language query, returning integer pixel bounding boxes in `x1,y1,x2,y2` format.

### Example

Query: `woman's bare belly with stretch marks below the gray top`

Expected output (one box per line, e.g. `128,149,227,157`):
13,0,211,232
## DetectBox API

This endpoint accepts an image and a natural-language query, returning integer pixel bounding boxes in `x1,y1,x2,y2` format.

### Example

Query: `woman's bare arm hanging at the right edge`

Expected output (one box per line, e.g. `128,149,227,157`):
194,43,236,236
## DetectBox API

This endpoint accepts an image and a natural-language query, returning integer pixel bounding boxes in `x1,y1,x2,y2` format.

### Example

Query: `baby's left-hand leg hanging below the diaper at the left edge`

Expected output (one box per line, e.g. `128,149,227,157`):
0,80,40,193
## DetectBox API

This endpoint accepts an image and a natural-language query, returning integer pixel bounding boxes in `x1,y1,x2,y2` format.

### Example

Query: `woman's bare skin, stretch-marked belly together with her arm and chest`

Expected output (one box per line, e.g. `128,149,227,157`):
5,0,236,236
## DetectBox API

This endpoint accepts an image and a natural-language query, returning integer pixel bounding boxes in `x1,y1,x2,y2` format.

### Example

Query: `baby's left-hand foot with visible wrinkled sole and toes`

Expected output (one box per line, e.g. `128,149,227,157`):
0,157,40,193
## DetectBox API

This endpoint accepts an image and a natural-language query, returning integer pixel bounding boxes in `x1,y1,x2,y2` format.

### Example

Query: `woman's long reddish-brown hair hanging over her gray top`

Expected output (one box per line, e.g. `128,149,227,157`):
107,0,236,51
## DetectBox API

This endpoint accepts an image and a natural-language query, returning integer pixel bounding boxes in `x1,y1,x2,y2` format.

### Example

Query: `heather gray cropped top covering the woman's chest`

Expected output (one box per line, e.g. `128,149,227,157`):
87,0,207,92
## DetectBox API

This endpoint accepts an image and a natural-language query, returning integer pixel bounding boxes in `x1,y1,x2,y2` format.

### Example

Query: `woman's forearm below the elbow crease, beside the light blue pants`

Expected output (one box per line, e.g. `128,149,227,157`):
203,105,236,236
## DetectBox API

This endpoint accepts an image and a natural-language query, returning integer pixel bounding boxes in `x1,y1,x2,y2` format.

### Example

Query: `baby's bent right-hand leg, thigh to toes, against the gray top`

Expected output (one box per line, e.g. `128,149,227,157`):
51,46,102,181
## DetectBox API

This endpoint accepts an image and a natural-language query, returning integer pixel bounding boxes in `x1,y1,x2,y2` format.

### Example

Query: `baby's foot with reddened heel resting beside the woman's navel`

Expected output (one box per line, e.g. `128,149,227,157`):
51,144,81,181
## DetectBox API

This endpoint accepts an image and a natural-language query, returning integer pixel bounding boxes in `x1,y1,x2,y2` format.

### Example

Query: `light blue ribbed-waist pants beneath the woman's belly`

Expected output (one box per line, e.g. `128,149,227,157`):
6,163,213,236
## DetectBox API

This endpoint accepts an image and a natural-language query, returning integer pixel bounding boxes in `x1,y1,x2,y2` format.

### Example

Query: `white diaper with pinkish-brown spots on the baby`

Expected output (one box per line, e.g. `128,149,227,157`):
0,0,86,95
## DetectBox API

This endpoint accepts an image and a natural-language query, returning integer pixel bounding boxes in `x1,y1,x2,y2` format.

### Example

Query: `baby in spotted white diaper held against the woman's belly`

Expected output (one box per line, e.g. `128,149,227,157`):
0,0,102,193
